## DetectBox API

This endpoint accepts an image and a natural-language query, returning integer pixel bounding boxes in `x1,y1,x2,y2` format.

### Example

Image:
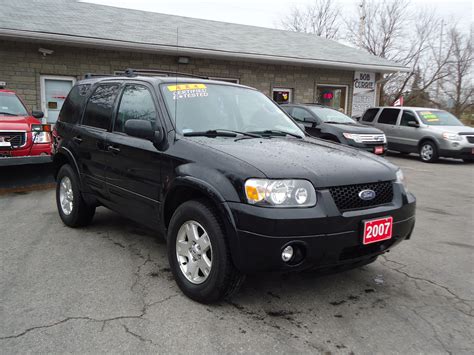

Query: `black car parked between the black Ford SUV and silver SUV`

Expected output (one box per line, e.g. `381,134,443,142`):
282,104,387,155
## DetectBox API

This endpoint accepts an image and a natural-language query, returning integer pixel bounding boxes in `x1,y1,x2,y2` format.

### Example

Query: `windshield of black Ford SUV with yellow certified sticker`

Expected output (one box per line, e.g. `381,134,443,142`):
161,83,304,137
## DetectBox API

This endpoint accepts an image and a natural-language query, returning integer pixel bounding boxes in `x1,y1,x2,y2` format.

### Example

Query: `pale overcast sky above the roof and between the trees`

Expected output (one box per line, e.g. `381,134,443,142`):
84,0,473,31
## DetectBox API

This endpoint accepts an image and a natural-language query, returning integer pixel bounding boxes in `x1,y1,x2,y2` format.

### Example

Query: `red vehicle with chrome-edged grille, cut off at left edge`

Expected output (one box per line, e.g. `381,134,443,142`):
0,83,51,166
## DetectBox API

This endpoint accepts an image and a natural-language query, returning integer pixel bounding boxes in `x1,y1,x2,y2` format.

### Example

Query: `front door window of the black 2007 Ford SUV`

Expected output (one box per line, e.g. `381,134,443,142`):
114,85,156,132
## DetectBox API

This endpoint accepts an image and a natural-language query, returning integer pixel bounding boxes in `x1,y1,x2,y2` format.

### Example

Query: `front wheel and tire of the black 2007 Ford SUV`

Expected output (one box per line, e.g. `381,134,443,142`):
168,200,245,303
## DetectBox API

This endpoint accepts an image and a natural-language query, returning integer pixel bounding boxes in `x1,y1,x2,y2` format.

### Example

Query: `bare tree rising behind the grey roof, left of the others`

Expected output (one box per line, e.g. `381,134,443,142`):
281,0,340,39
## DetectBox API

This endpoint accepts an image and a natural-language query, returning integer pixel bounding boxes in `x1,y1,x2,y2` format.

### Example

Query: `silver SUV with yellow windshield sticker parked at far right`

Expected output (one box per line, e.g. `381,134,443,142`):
360,107,474,163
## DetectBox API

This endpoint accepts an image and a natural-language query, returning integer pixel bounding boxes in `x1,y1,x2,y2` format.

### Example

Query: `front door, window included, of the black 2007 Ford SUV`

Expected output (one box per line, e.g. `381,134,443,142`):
106,82,162,226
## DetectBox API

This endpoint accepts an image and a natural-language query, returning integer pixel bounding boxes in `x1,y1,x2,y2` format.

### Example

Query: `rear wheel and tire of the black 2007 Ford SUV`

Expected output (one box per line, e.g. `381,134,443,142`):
56,164,95,228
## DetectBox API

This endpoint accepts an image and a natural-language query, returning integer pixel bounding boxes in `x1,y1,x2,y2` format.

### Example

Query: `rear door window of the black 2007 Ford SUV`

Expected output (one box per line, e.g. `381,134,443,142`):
82,84,119,129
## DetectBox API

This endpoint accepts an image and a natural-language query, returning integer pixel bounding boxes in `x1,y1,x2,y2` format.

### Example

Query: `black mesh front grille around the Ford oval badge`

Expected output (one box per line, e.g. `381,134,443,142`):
329,181,393,211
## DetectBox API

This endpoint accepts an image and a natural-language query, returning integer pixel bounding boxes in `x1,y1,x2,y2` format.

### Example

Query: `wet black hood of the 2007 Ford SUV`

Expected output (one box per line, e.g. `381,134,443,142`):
189,137,397,187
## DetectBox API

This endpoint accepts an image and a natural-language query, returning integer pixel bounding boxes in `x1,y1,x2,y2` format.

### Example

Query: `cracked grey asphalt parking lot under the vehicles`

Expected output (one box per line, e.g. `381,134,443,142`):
0,155,474,354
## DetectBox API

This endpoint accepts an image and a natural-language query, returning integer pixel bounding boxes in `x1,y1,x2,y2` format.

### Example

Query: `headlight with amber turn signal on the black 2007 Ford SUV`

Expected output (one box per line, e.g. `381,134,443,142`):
245,179,316,207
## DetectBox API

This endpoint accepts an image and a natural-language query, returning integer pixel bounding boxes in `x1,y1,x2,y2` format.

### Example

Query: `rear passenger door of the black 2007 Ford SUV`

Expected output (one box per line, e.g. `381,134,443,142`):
76,82,120,200
